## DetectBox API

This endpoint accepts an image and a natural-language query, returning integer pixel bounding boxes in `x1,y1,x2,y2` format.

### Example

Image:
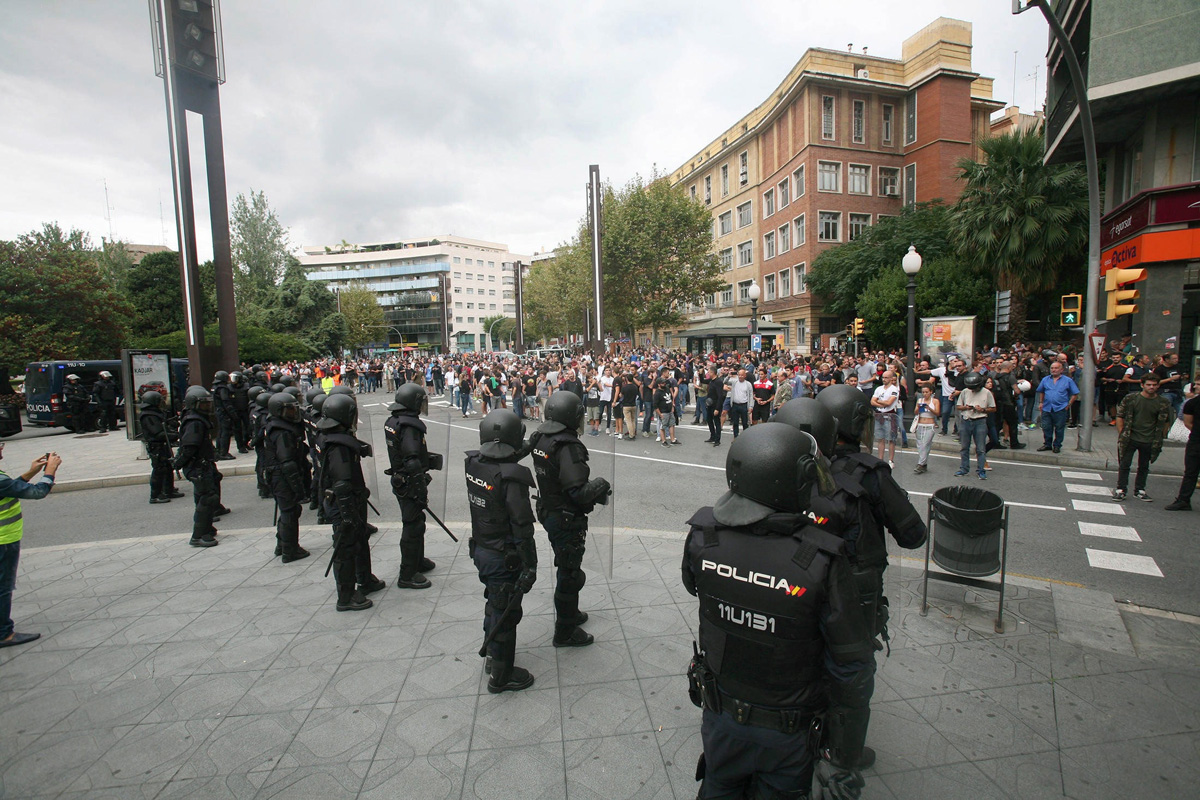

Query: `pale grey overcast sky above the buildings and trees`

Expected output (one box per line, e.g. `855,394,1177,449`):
0,0,1046,260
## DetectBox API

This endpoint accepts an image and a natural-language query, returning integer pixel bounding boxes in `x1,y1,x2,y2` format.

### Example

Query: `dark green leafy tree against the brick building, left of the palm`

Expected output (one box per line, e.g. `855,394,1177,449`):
808,201,954,319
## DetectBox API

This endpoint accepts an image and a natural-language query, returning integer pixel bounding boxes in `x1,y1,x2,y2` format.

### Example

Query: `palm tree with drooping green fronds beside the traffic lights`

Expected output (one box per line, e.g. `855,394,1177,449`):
950,128,1087,338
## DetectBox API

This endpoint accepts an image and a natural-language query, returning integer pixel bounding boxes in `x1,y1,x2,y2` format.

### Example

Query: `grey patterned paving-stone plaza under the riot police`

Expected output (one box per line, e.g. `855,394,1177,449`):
0,510,1200,800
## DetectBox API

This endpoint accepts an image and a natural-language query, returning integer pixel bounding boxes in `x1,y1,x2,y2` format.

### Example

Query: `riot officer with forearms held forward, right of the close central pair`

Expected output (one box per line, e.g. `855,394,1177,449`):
529,391,612,648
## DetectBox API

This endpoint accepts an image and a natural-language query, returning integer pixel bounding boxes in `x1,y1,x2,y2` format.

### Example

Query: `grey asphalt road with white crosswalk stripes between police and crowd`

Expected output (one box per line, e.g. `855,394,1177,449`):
18,403,1200,614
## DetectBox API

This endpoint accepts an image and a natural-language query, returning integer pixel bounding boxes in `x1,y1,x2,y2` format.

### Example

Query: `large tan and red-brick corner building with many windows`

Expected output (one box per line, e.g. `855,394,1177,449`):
662,18,1003,353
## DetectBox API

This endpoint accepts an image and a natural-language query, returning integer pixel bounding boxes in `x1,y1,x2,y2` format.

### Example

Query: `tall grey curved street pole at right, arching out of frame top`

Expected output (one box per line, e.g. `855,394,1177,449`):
1013,0,1100,451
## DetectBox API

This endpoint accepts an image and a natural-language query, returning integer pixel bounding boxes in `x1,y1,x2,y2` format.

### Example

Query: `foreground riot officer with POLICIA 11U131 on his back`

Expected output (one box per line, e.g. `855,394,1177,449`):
683,425,875,800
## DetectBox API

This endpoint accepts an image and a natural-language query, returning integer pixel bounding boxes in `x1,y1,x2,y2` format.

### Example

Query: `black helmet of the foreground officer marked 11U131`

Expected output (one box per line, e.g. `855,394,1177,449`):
713,425,822,525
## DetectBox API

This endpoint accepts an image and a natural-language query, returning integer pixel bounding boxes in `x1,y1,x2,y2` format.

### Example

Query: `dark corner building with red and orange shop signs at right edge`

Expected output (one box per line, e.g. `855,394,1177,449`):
1046,0,1200,378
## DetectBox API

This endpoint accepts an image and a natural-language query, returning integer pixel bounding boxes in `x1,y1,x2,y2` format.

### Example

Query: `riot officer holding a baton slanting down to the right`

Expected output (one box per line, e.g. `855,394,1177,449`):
383,384,442,589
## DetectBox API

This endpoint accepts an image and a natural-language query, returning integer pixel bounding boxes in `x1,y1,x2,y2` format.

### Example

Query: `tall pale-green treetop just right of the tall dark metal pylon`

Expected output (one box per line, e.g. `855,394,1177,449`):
229,190,288,304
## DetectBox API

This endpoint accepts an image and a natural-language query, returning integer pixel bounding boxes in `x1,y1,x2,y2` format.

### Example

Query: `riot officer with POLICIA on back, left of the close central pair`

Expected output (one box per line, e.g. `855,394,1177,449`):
465,410,538,694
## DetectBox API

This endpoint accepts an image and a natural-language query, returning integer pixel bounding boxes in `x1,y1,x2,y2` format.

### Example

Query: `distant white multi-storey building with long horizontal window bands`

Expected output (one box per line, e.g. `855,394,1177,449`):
299,235,529,353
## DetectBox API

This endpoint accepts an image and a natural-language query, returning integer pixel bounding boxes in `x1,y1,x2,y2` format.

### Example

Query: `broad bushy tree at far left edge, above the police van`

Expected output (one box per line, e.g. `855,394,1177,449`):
0,223,133,373
